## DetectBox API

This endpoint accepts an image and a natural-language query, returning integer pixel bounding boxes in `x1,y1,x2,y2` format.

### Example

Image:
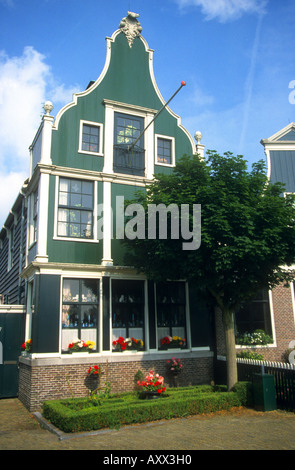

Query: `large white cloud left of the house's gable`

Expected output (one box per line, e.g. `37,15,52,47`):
0,46,77,226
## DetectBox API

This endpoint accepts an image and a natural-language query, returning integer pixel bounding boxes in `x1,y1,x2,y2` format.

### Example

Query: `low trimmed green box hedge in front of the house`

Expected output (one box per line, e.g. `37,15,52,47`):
43,382,253,433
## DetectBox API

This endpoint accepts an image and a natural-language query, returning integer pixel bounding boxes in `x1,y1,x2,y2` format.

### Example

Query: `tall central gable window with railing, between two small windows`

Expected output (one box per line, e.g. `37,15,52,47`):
114,113,145,176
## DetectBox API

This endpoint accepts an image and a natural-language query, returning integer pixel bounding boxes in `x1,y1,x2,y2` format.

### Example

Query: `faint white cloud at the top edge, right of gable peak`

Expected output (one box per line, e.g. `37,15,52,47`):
176,0,268,23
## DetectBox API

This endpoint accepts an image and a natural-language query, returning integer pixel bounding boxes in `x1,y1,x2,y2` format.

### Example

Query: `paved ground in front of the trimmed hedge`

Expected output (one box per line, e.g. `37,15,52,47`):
0,398,295,454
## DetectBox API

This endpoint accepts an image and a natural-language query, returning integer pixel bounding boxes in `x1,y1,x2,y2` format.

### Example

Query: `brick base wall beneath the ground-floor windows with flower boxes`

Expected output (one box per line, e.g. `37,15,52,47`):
19,352,213,411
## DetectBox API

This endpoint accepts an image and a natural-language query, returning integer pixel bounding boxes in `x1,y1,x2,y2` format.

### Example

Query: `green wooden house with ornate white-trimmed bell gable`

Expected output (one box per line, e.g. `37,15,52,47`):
1,12,213,409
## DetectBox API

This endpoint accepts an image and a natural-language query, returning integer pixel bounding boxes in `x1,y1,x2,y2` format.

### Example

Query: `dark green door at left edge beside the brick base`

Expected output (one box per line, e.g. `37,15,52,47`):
0,313,24,398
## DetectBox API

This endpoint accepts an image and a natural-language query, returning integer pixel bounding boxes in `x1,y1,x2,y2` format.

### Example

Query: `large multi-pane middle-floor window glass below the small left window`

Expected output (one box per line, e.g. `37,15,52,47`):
57,178,94,239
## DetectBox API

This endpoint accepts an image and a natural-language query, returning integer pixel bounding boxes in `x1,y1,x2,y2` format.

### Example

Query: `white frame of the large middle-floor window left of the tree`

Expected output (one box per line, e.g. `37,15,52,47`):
53,174,99,243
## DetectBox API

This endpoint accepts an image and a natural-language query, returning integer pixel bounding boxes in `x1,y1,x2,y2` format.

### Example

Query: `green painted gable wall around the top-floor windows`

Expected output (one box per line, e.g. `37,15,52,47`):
52,33,192,171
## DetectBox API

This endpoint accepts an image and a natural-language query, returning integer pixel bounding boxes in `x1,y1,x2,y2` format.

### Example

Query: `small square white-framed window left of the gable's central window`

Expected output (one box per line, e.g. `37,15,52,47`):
79,121,102,155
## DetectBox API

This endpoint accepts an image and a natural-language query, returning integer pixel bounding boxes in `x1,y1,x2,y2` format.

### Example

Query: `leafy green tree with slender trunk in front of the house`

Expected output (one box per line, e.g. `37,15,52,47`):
124,151,295,390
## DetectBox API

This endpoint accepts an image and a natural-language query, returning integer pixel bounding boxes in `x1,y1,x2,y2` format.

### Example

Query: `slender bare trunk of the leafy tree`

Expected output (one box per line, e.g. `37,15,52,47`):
222,310,238,391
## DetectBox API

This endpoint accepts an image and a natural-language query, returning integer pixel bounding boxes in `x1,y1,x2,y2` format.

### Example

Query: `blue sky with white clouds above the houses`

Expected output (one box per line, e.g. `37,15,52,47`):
0,0,295,225
